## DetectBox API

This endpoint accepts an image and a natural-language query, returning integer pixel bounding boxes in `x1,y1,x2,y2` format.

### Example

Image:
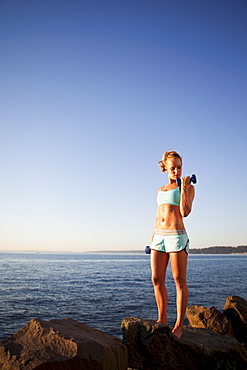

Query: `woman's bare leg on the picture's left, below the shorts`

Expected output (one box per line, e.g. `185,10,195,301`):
151,250,169,324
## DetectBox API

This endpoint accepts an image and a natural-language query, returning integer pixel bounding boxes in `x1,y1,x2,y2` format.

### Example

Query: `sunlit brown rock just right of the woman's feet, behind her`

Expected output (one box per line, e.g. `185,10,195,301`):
186,305,233,335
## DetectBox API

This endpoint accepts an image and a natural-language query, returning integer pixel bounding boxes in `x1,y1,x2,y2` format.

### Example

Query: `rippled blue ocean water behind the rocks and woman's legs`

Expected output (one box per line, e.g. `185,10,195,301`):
0,252,247,340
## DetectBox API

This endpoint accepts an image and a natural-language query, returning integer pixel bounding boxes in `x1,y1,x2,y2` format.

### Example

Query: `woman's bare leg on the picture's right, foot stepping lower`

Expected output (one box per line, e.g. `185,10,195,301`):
170,251,188,338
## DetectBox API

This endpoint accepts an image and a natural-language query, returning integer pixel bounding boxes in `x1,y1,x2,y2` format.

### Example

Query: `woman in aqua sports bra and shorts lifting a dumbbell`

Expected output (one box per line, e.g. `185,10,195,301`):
150,150,195,338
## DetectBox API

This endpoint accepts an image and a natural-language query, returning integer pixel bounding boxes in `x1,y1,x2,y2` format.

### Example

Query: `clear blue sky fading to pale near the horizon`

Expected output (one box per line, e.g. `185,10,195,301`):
0,0,247,252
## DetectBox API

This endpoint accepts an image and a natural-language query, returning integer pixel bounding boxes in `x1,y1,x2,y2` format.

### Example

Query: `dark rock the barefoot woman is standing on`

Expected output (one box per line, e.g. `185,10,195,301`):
122,317,247,370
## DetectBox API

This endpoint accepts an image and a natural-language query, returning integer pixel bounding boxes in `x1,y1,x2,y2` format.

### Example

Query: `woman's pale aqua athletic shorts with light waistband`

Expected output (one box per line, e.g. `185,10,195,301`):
150,229,190,254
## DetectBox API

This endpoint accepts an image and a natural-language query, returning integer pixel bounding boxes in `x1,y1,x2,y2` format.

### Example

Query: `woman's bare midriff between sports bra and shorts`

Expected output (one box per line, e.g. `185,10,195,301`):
154,204,184,230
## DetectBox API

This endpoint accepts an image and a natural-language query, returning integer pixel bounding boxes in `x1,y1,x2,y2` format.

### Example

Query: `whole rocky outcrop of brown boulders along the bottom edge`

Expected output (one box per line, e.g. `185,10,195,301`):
0,296,247,370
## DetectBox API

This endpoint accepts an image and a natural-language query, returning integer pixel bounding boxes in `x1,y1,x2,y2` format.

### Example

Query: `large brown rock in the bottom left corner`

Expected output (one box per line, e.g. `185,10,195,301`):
0,319,127,370
